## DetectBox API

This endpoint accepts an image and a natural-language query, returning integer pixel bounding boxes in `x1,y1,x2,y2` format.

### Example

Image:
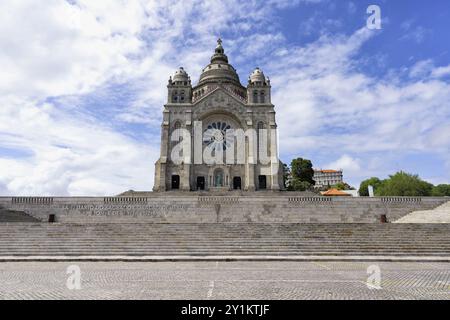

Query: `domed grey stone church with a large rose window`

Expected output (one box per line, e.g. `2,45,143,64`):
153,39,283,191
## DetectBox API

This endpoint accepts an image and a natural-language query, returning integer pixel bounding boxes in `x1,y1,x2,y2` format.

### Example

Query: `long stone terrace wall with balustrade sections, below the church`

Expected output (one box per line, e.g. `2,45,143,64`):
0,192,449,223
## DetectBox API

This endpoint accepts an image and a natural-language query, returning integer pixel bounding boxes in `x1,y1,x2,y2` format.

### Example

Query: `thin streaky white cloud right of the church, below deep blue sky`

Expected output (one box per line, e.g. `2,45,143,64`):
266,30,450,186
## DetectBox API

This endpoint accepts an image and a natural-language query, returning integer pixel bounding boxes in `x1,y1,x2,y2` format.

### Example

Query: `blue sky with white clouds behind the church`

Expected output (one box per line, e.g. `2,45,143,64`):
0,0,450,195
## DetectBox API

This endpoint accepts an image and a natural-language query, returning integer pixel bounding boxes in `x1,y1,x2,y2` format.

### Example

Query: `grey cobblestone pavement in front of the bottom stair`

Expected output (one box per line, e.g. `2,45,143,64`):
0,262,450,300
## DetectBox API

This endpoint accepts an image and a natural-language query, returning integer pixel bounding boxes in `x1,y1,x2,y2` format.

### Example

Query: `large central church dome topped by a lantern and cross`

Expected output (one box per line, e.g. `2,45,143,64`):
198,39,241,86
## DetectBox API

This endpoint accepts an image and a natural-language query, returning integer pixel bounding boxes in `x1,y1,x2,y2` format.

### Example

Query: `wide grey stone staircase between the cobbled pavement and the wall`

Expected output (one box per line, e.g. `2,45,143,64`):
0,223,450,257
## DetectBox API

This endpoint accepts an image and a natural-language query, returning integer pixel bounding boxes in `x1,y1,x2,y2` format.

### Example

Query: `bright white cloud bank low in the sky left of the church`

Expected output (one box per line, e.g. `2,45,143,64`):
0,95,159,195
